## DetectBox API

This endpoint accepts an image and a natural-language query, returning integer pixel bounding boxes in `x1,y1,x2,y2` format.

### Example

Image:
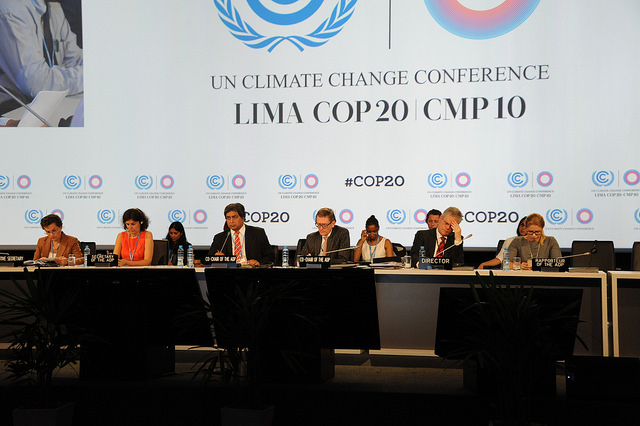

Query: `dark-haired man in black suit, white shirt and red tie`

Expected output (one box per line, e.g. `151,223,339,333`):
207,203,274,266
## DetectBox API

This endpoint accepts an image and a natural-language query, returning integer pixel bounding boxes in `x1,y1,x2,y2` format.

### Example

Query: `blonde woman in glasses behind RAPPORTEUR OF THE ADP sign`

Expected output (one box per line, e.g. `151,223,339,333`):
509,213,562,269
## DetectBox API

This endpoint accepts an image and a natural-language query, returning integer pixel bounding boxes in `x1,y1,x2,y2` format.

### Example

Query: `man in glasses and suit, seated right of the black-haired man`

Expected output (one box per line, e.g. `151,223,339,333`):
299,207,353,263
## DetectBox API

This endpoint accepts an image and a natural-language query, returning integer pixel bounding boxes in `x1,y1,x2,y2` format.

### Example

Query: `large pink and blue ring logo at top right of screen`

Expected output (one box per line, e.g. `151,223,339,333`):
424,0,540,40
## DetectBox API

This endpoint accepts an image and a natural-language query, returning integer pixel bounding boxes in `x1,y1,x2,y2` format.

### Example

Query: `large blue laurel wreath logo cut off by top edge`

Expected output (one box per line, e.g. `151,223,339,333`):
214,0,358,52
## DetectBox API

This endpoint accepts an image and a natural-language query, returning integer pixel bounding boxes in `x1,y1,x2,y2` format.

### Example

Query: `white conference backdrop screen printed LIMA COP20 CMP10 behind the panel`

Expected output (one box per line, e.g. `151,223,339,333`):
0,0,640,248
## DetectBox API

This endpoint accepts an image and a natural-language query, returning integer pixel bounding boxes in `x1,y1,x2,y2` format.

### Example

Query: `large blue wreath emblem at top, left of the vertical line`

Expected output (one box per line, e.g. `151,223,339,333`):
214,0,358,52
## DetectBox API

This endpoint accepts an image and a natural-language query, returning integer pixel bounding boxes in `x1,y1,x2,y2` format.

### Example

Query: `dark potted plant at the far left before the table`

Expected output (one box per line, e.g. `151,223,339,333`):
0,268,81,426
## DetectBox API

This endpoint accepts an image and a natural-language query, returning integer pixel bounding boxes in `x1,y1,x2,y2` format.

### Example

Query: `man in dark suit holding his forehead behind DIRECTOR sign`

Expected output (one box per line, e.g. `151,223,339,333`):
411,207,464,266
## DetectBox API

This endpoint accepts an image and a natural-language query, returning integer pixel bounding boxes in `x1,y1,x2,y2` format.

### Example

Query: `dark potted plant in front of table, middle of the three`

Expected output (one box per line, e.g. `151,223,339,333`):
183,281,310,426
